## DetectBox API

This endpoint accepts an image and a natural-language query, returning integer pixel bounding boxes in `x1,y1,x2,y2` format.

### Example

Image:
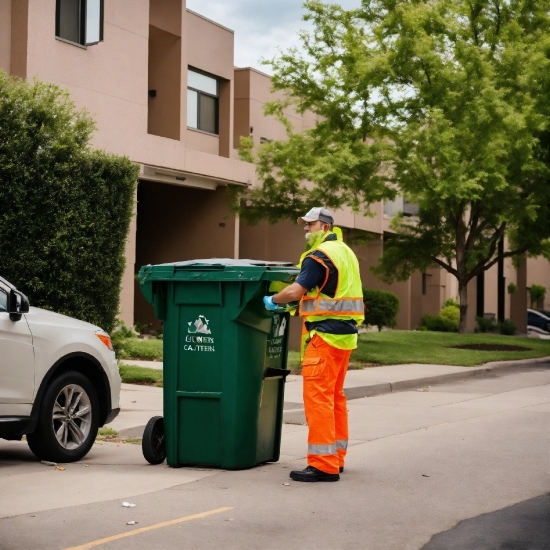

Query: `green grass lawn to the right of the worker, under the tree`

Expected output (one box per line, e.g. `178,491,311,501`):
351,330,550,367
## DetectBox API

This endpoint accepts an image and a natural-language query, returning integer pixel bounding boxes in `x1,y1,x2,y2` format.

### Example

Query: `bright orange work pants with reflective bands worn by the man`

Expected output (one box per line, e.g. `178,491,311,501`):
302,334,351,474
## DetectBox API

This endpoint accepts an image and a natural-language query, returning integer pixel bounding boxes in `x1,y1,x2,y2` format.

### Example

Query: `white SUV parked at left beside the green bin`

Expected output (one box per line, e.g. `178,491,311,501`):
0,277,120,462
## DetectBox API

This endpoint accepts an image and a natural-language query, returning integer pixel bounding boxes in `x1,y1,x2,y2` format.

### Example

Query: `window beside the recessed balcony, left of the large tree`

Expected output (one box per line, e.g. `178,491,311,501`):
187,69,219,134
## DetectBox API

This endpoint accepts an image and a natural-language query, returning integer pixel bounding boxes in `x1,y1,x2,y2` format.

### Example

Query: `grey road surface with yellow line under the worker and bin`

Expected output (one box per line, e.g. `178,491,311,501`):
0,365,550,550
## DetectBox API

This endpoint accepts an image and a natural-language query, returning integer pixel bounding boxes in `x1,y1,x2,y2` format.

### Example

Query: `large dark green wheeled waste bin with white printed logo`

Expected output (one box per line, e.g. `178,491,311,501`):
139,259,298,470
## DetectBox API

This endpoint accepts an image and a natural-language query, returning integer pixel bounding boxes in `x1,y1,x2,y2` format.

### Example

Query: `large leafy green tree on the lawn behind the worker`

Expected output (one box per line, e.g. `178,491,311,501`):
235,0,550,332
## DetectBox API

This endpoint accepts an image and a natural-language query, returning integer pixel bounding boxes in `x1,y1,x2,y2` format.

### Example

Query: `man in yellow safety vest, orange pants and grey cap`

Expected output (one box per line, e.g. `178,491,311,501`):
264,208,364,481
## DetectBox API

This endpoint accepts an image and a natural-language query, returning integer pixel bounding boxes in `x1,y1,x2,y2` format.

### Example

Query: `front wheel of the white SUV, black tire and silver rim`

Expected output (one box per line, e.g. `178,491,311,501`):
27,371,99,462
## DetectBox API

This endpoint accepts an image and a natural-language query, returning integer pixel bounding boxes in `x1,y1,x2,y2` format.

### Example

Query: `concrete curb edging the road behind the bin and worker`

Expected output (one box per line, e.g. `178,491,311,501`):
114,356,550,438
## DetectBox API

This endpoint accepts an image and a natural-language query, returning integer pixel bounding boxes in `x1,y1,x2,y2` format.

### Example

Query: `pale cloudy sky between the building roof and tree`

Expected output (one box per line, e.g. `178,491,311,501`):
187,0,361,73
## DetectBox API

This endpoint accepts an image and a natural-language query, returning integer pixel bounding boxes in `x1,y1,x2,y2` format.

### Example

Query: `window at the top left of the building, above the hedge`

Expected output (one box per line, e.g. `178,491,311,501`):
55,0,103,46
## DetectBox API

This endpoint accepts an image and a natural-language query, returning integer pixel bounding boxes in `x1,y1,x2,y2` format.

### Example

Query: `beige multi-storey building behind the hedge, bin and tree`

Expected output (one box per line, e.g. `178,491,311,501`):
0,0,550,344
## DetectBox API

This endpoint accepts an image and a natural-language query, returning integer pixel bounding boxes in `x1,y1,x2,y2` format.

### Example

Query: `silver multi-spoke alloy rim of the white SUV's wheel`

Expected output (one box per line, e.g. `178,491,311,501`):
52,384,92,450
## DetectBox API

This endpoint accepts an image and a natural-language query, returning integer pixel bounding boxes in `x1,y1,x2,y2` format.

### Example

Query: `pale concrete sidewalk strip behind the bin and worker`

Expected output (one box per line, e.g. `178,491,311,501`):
110,357,550,437
